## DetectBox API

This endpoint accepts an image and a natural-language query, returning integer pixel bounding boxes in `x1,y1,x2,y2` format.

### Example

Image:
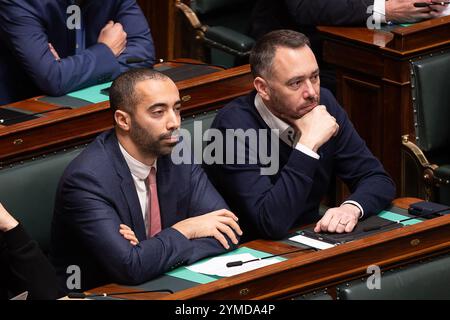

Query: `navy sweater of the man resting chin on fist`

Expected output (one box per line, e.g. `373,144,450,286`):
206,88,395,241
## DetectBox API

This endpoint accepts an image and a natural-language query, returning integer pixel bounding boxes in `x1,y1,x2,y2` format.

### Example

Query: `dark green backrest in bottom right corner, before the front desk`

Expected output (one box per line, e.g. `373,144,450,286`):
337,254,450,300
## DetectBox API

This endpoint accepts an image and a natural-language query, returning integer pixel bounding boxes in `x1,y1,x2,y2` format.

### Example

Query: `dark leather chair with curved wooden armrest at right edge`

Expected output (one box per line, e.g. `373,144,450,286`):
402,51,450,205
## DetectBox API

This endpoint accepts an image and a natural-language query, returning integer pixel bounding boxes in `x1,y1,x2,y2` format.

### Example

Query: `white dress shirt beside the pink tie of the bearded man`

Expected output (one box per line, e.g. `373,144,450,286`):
119,142,156,232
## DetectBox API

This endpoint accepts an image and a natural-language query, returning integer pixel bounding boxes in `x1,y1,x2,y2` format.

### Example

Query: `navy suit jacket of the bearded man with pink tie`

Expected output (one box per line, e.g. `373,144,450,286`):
51,131,233,293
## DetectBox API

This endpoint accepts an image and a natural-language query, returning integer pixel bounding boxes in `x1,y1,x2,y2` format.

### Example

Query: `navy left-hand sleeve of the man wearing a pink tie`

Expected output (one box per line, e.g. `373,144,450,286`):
58,172,202,284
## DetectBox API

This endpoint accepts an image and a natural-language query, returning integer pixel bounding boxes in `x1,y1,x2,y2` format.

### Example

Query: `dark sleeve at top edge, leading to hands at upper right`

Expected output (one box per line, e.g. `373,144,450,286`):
285,0,373,26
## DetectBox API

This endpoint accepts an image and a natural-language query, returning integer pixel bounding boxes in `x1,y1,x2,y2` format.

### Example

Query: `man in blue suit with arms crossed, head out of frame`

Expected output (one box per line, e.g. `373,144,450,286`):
0,0,155,105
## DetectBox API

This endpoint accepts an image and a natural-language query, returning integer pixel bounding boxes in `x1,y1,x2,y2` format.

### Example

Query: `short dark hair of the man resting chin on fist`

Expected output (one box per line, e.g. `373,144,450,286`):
250,30,311,78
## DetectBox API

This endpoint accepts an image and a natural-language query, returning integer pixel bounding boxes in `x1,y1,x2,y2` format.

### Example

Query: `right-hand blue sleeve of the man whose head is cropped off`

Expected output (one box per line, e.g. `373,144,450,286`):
115,0,155,72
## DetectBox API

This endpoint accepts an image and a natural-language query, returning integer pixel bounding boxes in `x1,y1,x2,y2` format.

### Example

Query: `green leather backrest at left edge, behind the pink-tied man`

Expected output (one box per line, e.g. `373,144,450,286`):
0,146,84,252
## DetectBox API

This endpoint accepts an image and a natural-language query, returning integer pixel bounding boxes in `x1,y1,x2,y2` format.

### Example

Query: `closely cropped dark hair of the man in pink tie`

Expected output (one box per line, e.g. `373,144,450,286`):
109,68,169,114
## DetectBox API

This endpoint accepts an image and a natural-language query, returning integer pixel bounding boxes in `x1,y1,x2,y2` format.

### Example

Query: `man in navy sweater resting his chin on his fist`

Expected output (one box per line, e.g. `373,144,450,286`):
207,30,395,240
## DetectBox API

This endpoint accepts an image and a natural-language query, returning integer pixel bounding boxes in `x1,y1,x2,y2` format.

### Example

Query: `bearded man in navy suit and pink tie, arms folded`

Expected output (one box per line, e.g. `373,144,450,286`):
51,69,242,292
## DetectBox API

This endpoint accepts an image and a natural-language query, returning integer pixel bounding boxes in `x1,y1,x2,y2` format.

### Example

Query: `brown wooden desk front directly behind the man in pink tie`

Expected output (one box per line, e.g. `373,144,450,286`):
0,60,253,165
